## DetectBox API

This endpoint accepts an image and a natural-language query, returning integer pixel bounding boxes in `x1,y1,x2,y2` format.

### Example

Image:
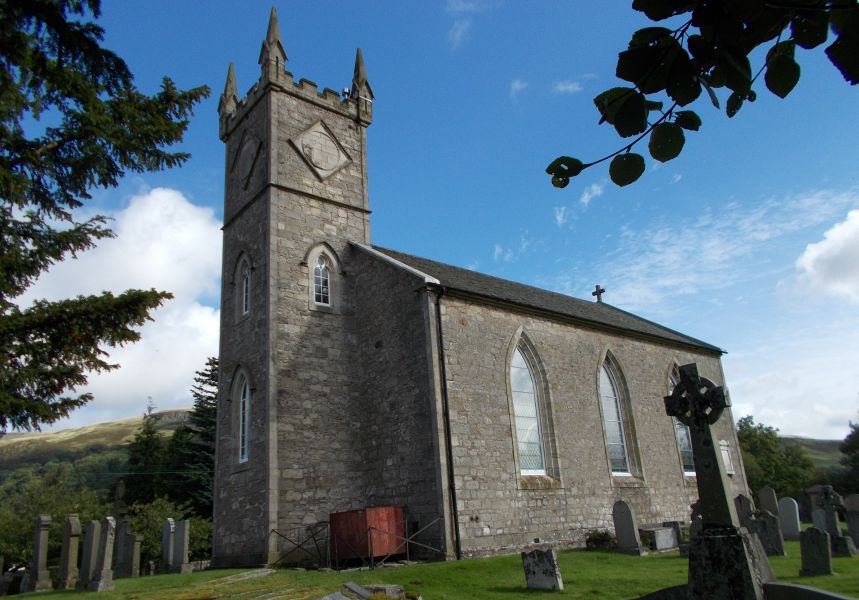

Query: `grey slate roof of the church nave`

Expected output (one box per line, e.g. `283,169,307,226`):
373,246,725,354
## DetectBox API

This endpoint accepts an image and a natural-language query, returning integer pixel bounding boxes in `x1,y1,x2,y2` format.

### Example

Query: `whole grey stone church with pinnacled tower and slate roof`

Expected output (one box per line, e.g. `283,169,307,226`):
214,10,747,566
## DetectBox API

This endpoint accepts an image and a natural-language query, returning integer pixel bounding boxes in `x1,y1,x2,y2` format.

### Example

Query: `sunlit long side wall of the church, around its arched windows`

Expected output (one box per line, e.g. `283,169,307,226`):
442,296,746,555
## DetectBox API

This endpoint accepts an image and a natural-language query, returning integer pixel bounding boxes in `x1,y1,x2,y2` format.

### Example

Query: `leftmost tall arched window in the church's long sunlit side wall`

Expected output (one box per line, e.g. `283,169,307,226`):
510,347,546,475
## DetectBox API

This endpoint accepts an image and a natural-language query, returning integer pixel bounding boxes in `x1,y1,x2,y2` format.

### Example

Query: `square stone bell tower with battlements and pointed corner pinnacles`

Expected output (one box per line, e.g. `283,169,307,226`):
214,8,373,566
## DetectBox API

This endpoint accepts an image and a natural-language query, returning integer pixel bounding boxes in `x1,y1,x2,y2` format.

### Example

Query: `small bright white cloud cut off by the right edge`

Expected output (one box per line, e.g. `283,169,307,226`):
796,210,859,303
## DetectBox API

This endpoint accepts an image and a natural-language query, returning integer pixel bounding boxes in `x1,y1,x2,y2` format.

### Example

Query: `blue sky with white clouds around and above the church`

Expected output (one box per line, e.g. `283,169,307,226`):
23,0,859,438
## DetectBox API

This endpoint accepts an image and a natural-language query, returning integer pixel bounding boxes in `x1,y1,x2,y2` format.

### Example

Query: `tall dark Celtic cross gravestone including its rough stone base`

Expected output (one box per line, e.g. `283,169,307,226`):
665,364,775,600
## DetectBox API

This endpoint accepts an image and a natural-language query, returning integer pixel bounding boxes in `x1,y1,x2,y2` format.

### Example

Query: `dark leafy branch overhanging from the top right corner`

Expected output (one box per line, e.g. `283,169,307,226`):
546,0,859,188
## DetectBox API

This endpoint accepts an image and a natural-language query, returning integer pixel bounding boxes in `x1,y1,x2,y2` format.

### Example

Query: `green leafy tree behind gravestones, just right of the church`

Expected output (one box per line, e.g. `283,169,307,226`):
737,416,814,498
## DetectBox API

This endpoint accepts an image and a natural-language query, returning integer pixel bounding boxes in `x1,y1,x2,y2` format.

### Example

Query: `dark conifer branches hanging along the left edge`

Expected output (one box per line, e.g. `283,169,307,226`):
0,0,208,431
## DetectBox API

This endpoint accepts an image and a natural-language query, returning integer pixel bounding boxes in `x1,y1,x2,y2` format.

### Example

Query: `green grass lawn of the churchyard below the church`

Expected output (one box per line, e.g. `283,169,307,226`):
23,542,859,600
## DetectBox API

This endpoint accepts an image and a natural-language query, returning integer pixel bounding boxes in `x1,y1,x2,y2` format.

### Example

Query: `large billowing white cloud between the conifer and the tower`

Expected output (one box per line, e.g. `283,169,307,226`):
21,188,221,427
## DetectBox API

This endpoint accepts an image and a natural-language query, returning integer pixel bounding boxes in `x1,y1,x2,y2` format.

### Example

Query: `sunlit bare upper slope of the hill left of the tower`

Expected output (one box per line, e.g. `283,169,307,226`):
0,409,190,472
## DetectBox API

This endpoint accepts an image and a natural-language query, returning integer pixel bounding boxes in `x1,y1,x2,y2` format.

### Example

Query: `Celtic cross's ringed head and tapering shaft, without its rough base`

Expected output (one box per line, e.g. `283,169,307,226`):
665,363,740,529
